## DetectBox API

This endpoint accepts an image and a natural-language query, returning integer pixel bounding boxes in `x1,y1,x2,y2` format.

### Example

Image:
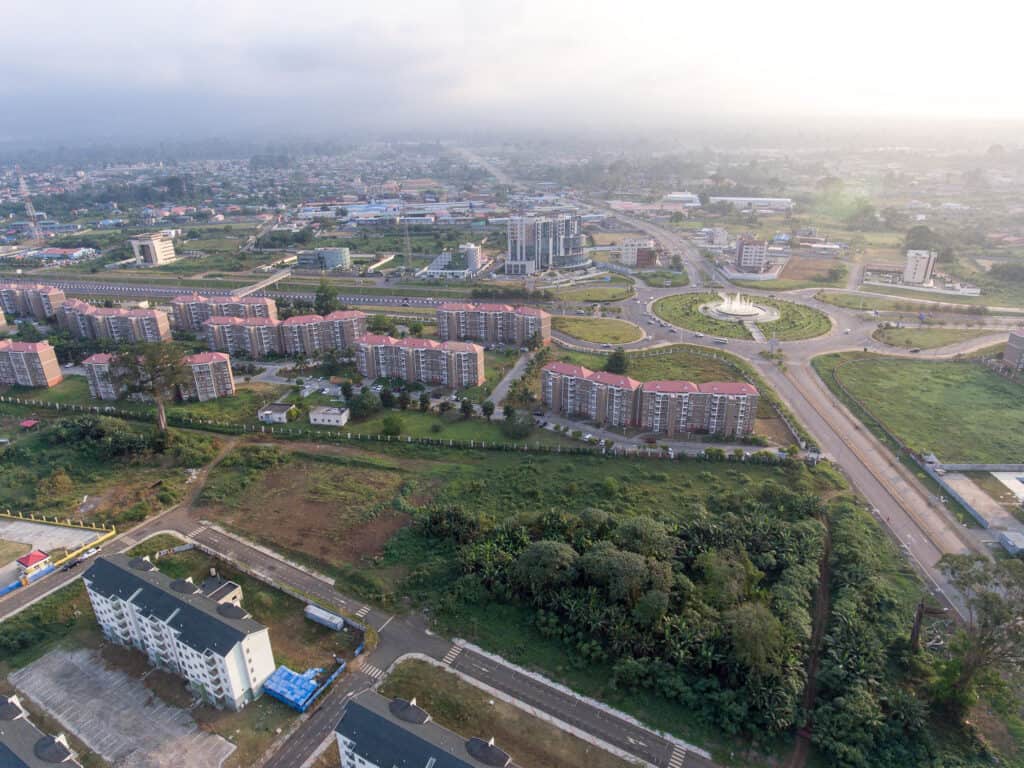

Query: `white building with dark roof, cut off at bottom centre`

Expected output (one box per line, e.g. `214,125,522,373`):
335,690,512,768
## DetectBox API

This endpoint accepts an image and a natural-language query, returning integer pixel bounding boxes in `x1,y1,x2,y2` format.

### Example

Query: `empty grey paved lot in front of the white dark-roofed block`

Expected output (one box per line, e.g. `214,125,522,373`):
10,650,234,768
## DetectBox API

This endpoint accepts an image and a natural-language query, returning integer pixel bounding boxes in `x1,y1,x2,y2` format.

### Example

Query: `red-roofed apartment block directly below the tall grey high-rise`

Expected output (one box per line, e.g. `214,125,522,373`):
437,302,551,347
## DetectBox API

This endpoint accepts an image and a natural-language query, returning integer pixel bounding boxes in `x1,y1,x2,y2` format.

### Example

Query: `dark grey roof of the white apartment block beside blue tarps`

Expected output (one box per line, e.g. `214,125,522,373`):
83,554,266,655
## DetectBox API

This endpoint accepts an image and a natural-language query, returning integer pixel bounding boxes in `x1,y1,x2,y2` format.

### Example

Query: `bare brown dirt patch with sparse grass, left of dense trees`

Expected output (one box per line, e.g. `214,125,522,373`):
196,446,424,563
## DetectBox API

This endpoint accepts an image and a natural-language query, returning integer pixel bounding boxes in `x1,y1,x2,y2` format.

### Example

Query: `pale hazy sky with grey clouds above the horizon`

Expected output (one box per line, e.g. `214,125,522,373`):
0,0,1024,143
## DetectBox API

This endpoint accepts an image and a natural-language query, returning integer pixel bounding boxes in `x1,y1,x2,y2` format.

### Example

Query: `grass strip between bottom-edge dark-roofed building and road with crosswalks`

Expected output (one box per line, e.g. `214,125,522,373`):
380,660,632,768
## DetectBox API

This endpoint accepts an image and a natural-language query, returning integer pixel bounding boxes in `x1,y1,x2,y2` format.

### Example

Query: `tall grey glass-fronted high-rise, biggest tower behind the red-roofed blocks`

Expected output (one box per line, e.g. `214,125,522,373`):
505,213,586,274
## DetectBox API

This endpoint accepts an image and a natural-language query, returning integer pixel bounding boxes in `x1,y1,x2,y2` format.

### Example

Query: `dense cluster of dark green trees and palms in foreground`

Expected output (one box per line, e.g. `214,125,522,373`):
420,478,824,734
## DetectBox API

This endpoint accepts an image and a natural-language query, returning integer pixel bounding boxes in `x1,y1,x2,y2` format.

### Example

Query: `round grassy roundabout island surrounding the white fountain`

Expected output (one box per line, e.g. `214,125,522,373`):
653,293,831,341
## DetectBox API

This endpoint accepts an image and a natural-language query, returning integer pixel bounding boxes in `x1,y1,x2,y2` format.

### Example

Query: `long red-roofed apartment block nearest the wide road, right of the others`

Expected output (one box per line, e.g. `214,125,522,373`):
541,362,758,437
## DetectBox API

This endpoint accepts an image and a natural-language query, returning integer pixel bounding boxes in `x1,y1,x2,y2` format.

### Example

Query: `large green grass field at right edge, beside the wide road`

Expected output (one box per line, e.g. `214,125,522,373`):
814,354,1024,463
